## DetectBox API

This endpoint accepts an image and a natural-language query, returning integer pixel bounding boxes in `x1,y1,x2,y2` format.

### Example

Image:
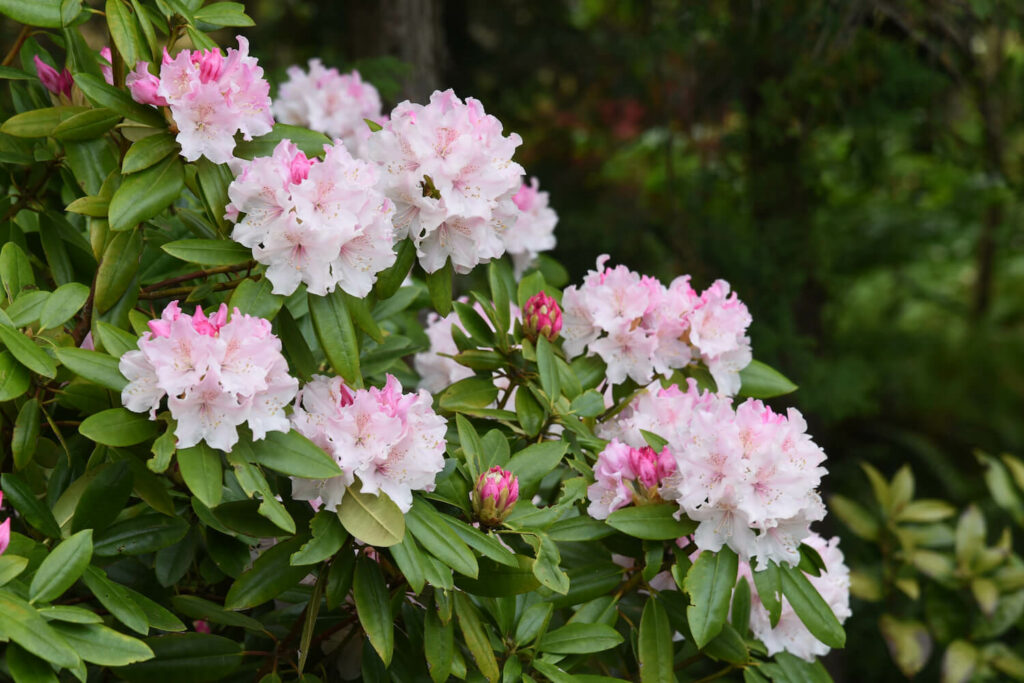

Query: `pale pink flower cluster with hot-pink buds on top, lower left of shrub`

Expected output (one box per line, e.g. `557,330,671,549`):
119,301,298,452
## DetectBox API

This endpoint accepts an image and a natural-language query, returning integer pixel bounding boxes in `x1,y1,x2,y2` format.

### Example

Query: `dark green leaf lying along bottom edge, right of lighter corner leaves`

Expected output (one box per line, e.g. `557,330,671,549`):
117,633,242,683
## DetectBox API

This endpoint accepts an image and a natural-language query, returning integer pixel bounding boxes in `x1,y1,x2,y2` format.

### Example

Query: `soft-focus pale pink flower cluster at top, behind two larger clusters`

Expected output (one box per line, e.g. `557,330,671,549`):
273,59,384,157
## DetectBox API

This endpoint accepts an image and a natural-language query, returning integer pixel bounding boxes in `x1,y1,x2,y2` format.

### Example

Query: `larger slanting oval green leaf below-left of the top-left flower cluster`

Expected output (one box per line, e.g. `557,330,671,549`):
108,157,186,232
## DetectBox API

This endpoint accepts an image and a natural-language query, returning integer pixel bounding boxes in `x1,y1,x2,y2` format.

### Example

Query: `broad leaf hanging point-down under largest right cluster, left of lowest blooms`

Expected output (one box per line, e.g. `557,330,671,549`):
683,548,738,649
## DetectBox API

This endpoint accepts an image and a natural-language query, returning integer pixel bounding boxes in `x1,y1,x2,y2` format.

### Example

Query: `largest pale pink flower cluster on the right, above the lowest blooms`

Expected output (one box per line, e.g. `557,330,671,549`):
599,380,825,564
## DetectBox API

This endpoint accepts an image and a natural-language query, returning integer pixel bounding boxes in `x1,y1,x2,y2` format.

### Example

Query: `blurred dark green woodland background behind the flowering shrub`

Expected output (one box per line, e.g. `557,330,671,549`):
235,0,1024,680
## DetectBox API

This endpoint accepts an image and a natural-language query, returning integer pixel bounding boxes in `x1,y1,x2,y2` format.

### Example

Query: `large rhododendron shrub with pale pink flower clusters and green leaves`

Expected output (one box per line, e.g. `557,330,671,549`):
0,5,851,682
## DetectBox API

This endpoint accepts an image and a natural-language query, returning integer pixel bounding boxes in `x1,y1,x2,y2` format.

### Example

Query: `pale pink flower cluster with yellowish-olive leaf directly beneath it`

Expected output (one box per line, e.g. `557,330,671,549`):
292,375,447,512
